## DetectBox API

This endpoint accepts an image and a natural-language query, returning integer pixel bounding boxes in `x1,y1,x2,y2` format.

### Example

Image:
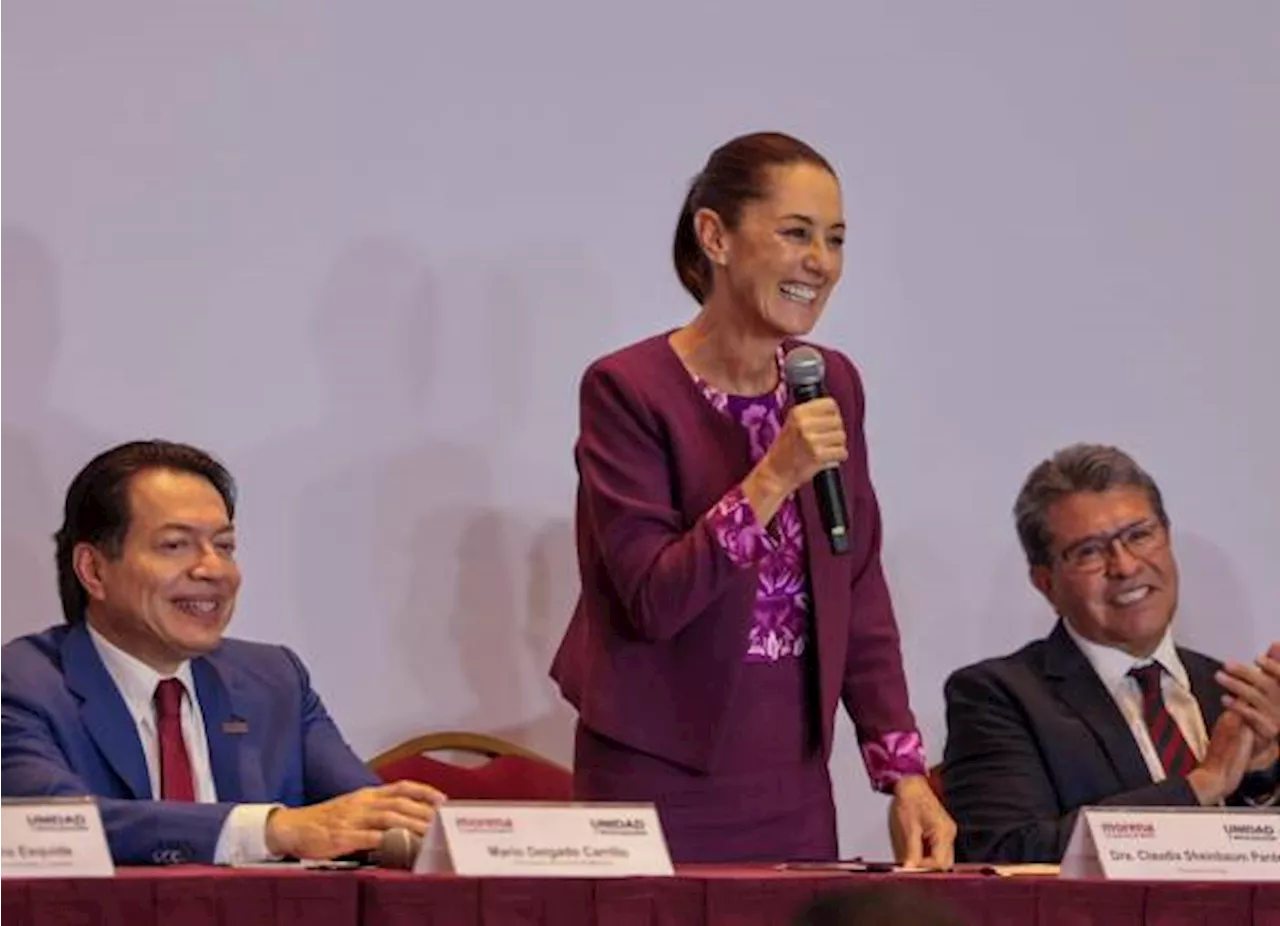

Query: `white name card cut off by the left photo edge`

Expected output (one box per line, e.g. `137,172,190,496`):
0,798,115,877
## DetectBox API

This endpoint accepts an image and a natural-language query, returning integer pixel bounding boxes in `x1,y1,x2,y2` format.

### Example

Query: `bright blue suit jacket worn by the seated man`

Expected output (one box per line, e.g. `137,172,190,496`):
0,624,378,865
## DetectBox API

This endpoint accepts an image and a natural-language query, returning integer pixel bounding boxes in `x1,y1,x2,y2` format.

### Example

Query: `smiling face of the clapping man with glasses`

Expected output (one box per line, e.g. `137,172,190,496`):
1032,485,1178,658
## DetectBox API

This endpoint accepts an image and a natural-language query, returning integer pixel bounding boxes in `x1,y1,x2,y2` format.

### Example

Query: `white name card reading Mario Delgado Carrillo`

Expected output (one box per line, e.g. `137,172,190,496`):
413,800,675,877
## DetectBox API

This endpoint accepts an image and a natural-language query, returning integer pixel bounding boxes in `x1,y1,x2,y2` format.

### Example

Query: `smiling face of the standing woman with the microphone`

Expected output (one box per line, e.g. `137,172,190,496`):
698,161,845,337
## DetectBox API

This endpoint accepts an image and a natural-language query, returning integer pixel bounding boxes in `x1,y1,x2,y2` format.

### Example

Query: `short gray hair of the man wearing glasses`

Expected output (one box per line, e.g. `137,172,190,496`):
1014,443,1169,566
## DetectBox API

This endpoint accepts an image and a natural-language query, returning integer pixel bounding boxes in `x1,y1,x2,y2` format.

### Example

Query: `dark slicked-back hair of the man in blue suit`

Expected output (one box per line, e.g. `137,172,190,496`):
54,441,236,624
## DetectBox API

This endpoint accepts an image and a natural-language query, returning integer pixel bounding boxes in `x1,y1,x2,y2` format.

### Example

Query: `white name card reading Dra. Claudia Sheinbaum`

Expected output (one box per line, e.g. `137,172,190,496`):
1061,807,1280,881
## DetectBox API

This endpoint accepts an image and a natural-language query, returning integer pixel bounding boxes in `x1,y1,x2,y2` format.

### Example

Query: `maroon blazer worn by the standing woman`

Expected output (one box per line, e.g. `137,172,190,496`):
552,334,915,771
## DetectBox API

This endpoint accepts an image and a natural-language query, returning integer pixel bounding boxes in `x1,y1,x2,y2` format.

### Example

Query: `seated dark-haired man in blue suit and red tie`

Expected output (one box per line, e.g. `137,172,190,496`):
0,441,442,865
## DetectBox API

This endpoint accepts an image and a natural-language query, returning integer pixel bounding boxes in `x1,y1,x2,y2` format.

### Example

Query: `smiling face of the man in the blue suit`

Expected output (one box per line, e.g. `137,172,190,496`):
73,469,241,675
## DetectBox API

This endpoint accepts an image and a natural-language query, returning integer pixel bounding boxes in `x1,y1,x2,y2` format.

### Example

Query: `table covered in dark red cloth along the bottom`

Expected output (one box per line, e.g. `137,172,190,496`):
0,866,1280,926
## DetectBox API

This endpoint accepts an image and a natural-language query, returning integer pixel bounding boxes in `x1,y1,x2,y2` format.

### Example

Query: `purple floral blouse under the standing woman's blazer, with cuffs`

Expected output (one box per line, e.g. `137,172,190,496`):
694,351,925,792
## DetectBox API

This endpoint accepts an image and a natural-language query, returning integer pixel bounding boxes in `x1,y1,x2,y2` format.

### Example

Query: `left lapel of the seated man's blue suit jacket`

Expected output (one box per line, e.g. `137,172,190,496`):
63,621,151,800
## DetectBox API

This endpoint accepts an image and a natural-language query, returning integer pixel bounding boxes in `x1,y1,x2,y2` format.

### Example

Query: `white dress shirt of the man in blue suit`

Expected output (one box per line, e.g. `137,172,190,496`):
88,626,279,865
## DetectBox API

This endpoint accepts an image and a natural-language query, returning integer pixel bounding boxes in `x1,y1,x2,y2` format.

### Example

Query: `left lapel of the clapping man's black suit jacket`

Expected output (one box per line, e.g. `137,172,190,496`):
1044,620,1151,790
